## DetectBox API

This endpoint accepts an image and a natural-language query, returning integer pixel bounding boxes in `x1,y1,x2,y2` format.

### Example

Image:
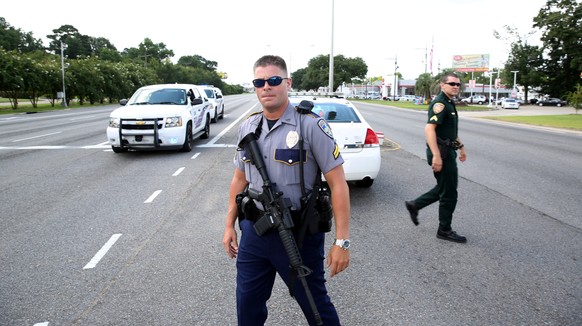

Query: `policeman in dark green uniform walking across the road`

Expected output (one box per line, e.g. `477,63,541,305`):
405,73,467,243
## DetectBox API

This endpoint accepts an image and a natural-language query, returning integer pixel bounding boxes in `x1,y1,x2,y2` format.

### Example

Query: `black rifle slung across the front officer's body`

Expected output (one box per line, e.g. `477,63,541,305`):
238,133,323,325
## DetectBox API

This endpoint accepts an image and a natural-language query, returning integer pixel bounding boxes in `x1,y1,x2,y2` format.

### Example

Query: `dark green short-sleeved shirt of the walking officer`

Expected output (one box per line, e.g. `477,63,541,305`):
427,92,459,141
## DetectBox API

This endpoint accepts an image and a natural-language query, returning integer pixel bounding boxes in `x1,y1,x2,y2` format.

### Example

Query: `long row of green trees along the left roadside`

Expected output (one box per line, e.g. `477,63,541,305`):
0,21,243,109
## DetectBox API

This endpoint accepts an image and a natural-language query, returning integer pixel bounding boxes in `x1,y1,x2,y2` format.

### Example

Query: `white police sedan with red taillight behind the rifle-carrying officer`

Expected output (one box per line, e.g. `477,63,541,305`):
289,96,382,187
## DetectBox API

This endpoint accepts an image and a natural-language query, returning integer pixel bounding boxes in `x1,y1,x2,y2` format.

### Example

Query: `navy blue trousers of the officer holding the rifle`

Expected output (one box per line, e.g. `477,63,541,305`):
236,220,340,326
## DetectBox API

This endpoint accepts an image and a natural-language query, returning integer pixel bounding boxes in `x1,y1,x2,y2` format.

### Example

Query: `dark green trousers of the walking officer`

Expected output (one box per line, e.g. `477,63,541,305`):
414,148,459,231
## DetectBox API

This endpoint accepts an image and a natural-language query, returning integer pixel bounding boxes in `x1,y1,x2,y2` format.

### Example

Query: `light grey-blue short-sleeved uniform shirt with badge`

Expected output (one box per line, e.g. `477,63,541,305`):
234,103,344,210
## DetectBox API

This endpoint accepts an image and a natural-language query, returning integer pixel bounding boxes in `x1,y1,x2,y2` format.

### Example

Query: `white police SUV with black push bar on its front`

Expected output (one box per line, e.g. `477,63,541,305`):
106,84,210,153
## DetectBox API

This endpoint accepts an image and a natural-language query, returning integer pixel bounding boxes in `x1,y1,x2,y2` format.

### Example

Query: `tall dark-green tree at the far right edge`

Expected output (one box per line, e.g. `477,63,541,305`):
533,0,582,97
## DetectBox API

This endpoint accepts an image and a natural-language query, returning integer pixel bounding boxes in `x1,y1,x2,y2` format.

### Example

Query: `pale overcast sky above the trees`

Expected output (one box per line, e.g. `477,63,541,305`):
0,0,546,84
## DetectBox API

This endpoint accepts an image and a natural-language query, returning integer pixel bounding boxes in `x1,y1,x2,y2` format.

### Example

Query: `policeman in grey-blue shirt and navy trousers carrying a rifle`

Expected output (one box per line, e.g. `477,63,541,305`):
223,55,350,326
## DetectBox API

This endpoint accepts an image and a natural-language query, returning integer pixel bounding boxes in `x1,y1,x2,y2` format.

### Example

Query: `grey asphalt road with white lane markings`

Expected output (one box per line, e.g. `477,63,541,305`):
0,95,582,325
